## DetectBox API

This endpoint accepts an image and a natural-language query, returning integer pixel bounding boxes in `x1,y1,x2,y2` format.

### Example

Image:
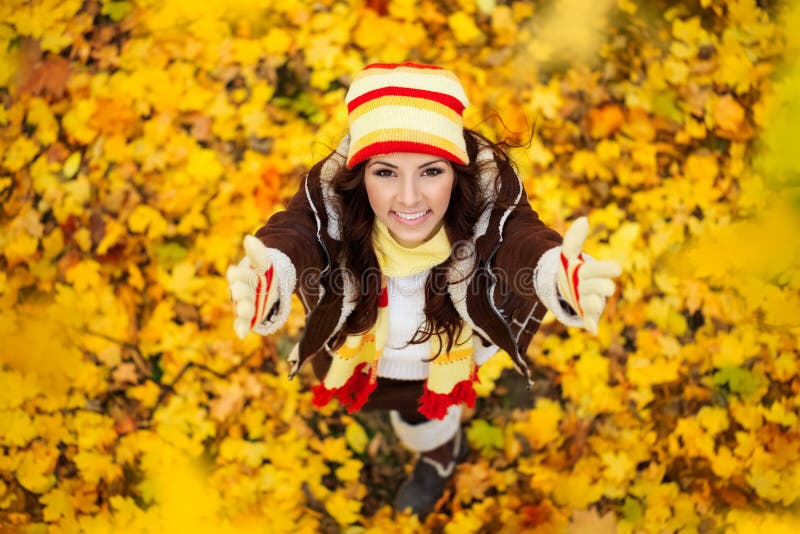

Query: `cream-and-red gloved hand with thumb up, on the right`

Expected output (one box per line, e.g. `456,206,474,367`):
558,217,622,334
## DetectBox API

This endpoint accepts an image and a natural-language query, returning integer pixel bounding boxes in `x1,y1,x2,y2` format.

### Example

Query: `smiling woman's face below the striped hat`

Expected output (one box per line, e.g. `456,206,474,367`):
364,152,455,248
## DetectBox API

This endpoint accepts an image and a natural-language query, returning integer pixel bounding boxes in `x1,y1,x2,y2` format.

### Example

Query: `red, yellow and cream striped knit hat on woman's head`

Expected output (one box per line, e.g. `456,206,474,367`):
345,63,469,169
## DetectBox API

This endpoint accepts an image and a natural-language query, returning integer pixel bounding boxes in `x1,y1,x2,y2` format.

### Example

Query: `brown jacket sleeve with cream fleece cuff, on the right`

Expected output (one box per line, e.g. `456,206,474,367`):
494,186,583,326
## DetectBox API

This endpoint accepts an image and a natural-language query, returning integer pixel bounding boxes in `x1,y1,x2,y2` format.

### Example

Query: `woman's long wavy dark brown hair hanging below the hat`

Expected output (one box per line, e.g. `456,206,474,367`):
332,128,512,357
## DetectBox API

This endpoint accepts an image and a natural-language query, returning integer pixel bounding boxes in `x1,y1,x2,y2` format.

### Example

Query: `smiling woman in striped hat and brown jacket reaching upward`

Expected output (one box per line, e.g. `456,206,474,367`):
228,63,619,516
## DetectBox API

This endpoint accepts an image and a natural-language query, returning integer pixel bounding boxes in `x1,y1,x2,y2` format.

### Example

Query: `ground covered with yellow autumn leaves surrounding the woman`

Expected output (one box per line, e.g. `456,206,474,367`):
0,0,800,533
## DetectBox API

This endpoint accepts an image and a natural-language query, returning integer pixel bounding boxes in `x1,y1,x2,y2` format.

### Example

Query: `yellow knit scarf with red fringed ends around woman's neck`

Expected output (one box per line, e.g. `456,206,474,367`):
312,219,477,419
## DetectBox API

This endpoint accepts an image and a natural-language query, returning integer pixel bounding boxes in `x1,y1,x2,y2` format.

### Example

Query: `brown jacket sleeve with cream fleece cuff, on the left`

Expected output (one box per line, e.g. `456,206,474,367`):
253,177,326,335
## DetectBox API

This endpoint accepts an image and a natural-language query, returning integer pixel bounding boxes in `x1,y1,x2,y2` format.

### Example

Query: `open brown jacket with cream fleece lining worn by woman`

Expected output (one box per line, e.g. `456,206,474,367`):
255,132,561,384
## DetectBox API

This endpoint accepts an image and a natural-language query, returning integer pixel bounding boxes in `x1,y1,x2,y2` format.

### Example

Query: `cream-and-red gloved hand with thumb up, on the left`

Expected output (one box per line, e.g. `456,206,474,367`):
227,235,277,338
